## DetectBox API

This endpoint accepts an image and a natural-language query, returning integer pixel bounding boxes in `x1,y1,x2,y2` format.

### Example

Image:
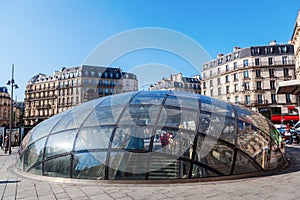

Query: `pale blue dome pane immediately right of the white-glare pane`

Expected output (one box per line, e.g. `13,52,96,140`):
75,127,113,151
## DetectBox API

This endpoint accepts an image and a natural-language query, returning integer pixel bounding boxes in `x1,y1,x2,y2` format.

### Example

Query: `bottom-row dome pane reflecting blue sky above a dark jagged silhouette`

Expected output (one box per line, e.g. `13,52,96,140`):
73,152,106,179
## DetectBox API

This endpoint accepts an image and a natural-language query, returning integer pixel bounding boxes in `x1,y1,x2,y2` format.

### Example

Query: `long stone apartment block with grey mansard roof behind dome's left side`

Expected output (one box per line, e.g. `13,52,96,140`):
24,65,138,127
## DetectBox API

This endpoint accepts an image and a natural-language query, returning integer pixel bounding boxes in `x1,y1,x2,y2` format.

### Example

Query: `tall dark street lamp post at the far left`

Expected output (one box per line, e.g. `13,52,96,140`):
7,64,19,154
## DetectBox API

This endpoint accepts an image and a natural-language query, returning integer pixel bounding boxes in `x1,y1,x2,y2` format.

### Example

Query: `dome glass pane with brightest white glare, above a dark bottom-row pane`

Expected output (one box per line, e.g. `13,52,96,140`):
45,130,77,157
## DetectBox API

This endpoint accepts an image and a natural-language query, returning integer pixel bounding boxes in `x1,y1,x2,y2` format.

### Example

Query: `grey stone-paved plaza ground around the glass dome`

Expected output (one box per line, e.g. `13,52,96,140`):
0,145,300,200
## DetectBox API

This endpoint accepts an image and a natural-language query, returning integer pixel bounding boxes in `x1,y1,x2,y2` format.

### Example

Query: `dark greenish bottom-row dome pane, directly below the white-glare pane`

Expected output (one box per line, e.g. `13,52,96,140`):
44,155,71,178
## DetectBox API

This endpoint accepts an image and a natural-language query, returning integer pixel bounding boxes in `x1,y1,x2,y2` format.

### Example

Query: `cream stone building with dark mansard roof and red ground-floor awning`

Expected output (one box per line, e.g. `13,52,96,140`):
201,41,298,123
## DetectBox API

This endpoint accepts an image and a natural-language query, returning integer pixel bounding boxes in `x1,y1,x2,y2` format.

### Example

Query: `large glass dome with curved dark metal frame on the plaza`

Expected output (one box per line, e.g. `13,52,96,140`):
16,91,286,180
